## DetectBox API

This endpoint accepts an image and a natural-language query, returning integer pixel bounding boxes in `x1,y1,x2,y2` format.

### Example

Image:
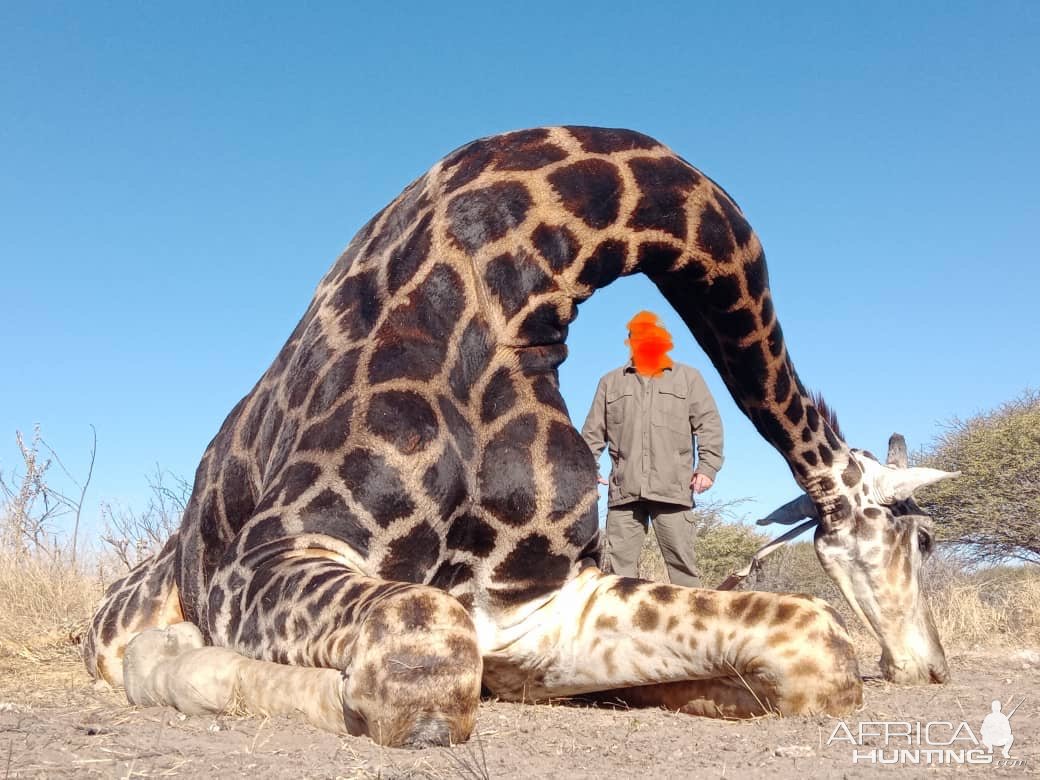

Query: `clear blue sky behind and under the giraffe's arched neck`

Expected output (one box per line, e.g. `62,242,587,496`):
0,1,1040,544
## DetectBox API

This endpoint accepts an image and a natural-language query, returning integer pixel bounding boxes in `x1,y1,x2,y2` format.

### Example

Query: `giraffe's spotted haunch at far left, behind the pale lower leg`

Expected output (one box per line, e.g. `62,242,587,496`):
83,534,184,687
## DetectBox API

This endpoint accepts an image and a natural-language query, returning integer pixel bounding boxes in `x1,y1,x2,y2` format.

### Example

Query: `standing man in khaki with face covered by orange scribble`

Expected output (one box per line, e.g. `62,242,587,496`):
581,311,723,587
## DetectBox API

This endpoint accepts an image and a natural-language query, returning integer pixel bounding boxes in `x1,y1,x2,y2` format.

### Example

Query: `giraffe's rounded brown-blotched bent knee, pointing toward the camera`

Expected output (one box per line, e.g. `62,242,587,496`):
343,587,482,748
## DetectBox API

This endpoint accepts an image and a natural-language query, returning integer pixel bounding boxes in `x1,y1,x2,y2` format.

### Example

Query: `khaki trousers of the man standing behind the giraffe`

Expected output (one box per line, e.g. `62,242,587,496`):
606,500,701,588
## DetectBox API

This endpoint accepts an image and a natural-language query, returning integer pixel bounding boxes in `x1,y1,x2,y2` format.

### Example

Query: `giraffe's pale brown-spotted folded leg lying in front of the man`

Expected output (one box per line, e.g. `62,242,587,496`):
482,568,862,718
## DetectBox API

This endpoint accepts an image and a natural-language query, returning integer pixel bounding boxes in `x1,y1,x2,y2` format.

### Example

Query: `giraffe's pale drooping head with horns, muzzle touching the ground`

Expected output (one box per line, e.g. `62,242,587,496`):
814,434,957,684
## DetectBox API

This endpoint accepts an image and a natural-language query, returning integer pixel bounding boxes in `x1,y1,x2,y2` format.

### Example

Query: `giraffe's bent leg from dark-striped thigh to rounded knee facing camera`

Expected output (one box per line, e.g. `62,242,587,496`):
209,537,482,747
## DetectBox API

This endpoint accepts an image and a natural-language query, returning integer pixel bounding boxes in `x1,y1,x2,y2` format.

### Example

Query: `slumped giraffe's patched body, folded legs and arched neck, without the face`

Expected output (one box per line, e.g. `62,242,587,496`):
84,127,952,747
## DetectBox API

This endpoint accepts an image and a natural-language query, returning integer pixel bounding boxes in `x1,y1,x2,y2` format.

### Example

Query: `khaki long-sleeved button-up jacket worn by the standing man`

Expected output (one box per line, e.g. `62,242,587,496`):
581,363,723,506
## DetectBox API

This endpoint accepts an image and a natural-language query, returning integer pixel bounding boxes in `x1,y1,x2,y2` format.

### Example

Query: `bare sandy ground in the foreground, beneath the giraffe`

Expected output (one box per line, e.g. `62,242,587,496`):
0,651,1040,778
